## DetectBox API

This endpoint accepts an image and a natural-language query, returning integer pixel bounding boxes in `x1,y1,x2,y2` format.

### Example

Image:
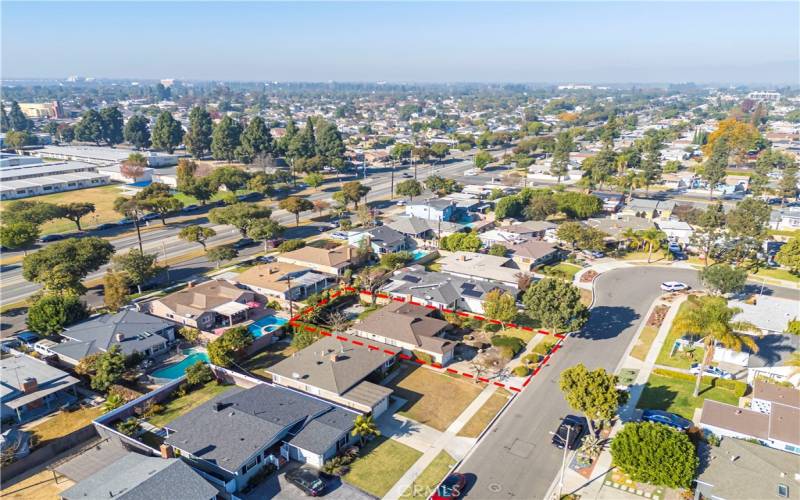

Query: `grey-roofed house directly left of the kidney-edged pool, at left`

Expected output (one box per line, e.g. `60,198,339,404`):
47,309,175,366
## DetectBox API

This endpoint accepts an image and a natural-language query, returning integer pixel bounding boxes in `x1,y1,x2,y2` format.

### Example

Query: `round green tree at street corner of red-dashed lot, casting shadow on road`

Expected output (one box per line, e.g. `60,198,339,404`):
522,278,589,332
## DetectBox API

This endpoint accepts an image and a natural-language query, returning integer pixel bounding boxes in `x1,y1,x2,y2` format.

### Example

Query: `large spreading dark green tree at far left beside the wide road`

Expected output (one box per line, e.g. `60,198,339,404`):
22,236,114,290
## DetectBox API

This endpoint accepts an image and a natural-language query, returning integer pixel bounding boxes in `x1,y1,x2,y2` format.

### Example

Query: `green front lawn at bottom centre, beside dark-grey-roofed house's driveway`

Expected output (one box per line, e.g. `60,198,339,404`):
342,437,422,498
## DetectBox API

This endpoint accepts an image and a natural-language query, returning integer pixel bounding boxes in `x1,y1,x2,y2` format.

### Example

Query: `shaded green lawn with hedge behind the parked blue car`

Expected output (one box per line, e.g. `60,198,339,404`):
637,374,739,420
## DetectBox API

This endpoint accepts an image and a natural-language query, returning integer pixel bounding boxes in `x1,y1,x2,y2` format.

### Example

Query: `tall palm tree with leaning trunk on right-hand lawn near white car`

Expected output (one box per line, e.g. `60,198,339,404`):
674,297,760,397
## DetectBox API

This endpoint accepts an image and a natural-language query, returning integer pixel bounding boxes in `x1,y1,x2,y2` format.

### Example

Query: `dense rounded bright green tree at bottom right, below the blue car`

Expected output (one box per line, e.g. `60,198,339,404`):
611,422,699,489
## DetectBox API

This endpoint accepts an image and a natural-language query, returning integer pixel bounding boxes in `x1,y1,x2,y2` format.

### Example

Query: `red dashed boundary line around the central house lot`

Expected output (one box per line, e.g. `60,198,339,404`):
289,287,566,393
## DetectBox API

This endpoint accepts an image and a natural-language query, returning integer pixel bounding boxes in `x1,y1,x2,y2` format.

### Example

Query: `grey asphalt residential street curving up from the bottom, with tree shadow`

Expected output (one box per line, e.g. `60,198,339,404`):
458,267,798,499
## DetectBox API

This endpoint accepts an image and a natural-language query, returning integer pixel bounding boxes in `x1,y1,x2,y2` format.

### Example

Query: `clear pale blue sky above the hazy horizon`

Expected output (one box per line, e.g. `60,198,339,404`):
0,0,800,85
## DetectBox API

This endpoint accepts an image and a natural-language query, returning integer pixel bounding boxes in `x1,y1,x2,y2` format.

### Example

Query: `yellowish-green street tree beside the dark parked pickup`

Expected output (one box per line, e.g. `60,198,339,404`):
559,363,624,436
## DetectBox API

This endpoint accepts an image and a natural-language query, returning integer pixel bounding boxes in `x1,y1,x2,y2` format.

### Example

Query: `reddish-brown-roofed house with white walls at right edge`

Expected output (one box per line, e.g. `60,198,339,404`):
700,380,800,455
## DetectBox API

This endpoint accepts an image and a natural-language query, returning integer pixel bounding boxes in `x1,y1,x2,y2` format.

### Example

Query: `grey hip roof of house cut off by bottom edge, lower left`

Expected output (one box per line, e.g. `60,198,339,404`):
60,452,219,500
